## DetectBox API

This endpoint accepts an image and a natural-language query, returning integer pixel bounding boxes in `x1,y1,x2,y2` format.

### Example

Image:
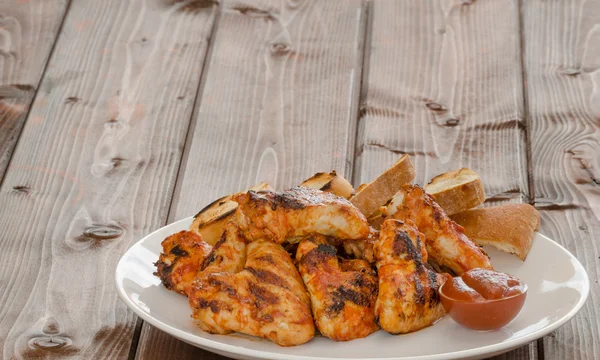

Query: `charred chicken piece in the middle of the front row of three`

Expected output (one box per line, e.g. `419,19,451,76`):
296,234,379,341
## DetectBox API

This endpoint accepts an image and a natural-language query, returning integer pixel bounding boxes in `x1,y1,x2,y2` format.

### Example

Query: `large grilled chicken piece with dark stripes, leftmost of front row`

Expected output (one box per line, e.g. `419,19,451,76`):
188,223,315,346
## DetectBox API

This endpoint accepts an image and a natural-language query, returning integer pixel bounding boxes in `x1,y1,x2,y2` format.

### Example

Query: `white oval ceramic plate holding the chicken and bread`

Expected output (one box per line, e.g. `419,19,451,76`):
116,218,590,360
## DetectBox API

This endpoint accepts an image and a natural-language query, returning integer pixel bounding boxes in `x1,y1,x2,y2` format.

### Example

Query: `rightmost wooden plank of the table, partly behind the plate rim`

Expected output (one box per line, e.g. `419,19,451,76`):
522,0,600,360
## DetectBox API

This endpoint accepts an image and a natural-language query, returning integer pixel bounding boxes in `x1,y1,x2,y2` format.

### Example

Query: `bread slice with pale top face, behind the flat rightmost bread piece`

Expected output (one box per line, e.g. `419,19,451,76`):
425,168,485,215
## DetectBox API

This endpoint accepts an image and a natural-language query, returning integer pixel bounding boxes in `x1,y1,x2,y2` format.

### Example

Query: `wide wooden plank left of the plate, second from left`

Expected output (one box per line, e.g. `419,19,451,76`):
0,0,215,359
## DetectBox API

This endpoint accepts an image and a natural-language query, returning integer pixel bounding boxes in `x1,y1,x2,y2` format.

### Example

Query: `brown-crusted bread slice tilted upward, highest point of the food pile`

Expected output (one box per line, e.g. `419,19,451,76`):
350,154,415,217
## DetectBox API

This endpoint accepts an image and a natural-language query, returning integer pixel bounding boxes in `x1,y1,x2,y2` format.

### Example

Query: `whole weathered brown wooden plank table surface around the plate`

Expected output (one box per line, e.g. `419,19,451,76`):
0,0,600,360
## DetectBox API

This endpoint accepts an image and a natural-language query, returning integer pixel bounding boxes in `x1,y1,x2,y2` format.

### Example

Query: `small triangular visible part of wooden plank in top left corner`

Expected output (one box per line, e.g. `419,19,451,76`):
0,0,68,180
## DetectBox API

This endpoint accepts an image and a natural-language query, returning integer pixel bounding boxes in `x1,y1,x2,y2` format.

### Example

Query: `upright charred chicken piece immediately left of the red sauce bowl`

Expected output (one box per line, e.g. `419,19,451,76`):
375,219,451,334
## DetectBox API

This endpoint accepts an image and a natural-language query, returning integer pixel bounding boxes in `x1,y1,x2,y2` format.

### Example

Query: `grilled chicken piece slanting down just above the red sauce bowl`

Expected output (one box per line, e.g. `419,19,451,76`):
384,185,492,275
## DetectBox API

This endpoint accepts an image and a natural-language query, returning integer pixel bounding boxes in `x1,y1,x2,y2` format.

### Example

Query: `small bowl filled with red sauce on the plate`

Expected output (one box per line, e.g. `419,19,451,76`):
439,269,527,330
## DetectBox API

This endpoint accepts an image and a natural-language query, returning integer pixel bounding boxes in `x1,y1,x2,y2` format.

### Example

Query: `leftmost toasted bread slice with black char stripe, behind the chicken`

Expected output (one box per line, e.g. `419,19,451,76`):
190,183,271,245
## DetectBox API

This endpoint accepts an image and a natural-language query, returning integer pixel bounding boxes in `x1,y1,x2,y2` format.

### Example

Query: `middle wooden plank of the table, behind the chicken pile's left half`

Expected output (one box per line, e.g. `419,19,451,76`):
137,0,366,359
